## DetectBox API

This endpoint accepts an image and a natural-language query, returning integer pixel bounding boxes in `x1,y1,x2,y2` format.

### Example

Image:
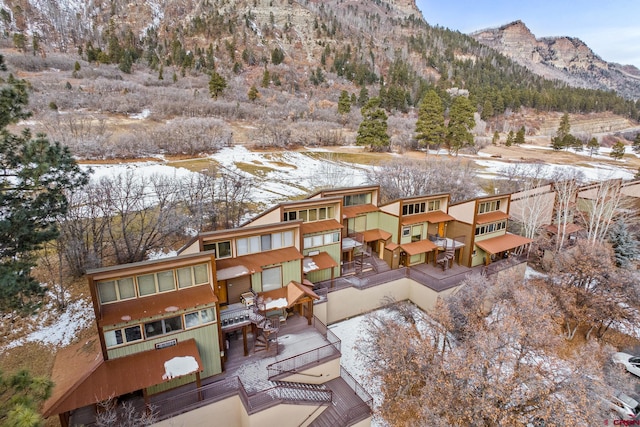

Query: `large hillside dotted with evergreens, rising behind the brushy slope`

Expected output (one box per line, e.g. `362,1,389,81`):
0,0,638,130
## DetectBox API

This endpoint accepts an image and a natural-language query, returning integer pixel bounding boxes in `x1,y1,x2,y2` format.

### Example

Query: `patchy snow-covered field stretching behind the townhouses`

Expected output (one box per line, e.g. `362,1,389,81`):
83,145,635,213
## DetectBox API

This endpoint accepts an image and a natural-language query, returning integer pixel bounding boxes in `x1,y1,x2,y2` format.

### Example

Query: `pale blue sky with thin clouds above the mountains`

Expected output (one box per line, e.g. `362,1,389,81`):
416,0,640,68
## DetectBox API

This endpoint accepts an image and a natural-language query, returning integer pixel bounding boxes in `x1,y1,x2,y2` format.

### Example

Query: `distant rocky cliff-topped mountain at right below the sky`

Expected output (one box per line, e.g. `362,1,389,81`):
471,21,640,99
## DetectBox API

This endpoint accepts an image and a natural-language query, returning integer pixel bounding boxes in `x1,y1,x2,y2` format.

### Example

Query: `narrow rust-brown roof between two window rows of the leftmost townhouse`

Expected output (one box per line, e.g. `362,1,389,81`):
97,284,218,326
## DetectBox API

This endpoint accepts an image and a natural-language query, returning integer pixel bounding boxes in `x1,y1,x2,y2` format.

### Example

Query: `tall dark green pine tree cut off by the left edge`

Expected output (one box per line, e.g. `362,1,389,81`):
0,61,87,311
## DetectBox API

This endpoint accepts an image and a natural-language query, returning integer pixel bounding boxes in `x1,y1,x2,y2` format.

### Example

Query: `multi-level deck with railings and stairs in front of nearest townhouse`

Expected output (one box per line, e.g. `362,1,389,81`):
70,314,371,426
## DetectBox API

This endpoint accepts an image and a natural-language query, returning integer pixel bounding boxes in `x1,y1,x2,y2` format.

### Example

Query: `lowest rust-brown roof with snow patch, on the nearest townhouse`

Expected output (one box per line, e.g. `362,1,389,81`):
43,338,202,418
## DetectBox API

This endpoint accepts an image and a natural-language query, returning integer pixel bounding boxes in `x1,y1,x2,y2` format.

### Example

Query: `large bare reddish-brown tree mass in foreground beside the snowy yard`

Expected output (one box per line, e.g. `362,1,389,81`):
358,280,611,426
